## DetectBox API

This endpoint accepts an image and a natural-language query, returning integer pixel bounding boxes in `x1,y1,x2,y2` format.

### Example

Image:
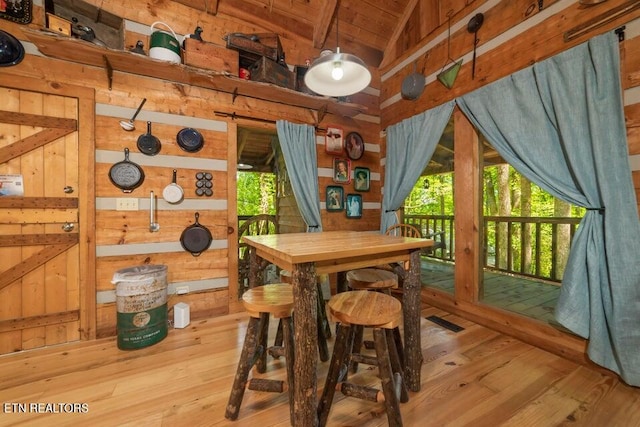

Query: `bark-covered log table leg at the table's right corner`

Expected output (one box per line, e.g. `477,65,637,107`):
402,250,422,391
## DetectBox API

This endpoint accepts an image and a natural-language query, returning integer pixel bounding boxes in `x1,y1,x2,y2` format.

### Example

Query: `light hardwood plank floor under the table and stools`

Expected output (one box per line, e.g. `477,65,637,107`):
0,308,640,427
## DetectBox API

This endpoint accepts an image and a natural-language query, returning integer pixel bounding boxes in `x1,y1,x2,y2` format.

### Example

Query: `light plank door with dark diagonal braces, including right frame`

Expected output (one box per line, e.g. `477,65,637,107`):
0,74,95,354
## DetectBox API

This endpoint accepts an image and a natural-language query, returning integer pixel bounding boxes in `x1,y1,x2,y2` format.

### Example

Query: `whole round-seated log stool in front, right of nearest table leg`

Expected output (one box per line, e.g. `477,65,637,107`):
318,291,408,427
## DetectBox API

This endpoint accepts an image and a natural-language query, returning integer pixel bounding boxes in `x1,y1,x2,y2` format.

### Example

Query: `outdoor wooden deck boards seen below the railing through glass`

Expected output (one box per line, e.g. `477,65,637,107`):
422,258,560,327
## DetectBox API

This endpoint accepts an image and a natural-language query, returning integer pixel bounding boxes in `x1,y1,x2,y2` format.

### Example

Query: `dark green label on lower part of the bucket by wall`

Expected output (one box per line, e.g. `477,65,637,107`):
117,304,168,350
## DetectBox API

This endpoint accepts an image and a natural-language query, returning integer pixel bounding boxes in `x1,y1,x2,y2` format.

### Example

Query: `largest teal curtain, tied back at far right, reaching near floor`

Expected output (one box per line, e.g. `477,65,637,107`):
457,33,640,386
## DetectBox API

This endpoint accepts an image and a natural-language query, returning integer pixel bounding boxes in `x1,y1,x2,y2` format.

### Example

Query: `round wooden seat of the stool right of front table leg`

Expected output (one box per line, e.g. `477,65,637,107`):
328,291,402,329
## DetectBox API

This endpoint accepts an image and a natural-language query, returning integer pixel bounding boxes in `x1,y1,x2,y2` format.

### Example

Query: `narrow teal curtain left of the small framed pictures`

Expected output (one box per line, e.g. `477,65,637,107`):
276,120,322,232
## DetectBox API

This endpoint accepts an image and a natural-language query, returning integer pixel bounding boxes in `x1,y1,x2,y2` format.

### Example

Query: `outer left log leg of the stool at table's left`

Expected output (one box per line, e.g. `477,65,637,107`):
224,317,260,420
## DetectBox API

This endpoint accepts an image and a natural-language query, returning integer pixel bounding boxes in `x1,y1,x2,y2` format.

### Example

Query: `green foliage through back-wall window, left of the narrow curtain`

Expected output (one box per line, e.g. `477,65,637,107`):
236,172,276,216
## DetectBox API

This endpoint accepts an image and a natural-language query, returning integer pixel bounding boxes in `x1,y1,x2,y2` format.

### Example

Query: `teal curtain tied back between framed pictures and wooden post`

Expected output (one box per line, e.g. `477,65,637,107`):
380,101,455,233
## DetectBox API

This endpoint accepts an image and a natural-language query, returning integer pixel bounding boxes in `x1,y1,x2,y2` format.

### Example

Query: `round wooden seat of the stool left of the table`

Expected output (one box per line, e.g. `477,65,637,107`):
242,283,293,318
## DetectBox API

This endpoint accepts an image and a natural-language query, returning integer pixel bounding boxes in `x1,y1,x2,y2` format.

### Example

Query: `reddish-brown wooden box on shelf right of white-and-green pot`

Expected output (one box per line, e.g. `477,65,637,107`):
183,38,238,76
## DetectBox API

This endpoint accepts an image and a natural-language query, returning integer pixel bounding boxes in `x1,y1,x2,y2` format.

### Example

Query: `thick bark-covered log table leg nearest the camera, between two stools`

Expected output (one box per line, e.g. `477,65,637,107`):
292,263,318,427
